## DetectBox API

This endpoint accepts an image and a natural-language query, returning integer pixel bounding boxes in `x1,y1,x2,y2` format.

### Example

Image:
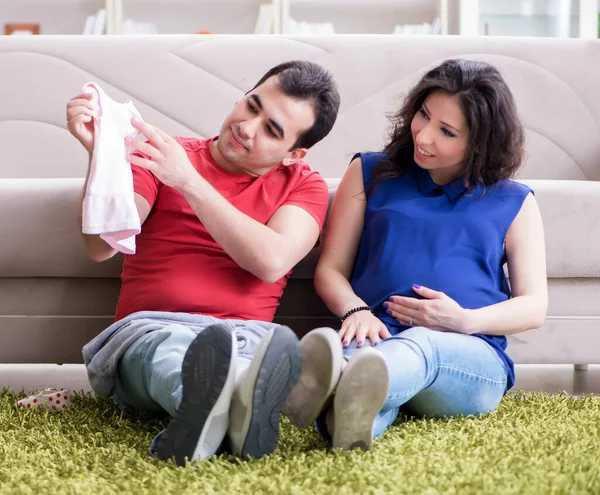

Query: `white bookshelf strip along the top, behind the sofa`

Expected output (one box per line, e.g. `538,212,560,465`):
0,0,600,38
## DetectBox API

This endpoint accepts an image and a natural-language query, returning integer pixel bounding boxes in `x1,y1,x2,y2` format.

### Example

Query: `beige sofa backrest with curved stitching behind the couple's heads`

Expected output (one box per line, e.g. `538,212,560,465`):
0,35,600,180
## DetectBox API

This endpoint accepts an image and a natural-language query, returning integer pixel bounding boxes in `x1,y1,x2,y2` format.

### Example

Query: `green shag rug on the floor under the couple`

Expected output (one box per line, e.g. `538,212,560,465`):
0,390,600,495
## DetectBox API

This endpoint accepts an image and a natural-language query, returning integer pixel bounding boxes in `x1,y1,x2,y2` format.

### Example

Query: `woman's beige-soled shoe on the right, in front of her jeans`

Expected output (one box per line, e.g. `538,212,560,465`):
333,348,389,450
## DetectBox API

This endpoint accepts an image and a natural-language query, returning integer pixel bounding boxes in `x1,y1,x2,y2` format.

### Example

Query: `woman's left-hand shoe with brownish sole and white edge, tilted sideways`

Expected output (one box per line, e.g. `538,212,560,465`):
283,328,344,428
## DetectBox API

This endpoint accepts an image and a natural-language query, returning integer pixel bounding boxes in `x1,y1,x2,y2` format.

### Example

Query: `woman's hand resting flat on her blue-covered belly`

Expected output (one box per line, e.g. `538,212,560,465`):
383,285,469,333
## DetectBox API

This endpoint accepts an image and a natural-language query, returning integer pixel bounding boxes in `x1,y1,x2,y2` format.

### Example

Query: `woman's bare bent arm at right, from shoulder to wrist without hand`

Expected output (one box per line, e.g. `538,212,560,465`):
465,194,548,335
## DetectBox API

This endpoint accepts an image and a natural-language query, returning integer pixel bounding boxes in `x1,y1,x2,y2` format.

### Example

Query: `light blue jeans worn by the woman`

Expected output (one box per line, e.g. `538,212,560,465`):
344,327,506,438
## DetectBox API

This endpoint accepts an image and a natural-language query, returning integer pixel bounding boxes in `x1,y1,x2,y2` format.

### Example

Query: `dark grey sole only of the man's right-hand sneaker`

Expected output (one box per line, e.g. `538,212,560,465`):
234,326,302,459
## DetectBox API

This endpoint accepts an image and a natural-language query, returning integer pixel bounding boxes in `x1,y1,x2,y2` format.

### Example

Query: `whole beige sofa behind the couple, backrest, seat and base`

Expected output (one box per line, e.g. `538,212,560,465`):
0,35,600,388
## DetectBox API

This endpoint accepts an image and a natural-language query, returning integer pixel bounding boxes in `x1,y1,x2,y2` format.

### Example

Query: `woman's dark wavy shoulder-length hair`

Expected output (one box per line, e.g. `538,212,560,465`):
372,59,524,189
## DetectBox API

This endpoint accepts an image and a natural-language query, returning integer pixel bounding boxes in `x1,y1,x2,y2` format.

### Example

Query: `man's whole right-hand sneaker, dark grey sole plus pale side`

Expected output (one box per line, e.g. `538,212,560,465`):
227,326,302,459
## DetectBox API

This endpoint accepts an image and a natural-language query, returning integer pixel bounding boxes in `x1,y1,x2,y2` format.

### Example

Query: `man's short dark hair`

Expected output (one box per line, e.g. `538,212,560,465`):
250,60,340,149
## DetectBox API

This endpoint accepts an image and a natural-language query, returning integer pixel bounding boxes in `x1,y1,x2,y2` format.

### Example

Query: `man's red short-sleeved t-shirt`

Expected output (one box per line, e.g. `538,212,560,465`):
116,138,328,321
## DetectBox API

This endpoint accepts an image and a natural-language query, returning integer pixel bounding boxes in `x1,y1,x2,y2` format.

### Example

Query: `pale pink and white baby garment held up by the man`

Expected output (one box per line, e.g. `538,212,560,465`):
82,82,142,254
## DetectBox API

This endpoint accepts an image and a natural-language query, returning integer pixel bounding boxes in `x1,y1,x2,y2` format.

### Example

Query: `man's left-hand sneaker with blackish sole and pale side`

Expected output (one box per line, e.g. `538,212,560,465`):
157,325,237,466
